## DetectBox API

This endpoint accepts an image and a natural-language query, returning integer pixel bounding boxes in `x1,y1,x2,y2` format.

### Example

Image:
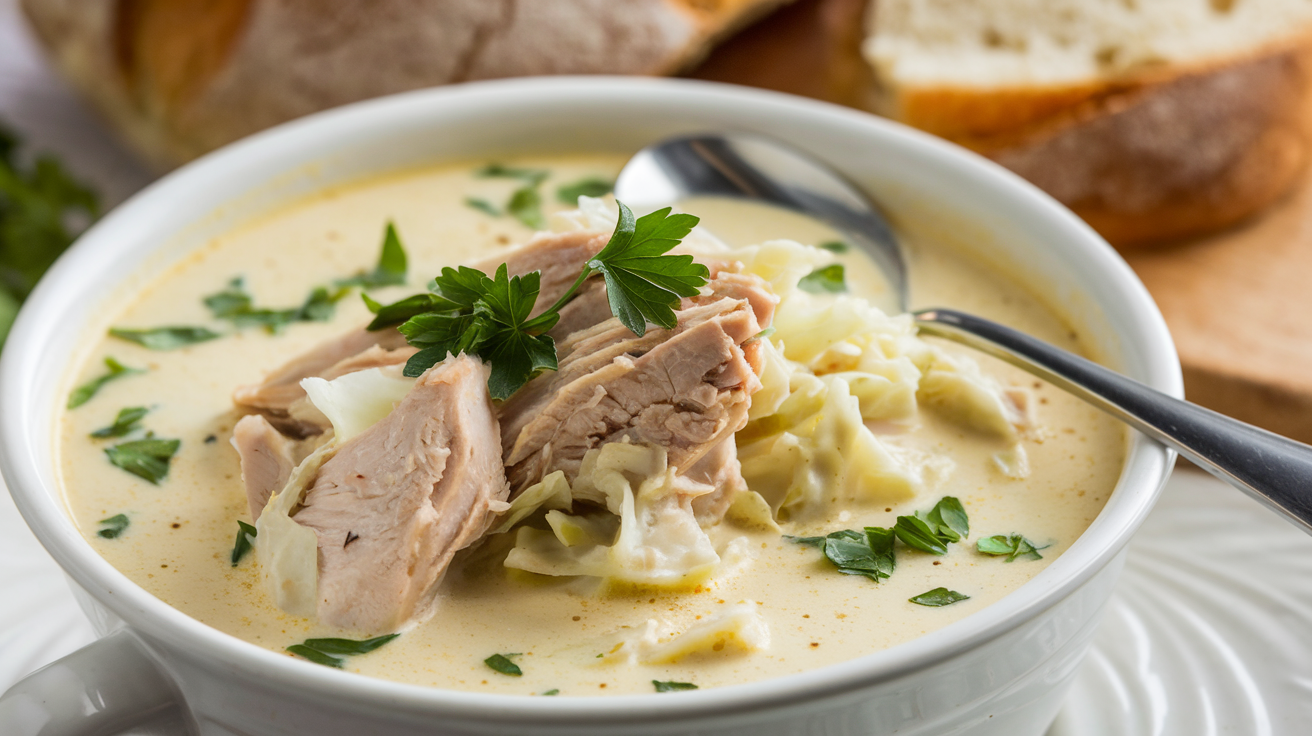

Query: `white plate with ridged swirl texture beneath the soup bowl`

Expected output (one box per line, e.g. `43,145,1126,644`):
0,470,1312,736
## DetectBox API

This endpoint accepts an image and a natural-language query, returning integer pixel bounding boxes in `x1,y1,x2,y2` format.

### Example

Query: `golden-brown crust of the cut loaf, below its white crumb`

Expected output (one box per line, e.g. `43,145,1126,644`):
882,37,1312,248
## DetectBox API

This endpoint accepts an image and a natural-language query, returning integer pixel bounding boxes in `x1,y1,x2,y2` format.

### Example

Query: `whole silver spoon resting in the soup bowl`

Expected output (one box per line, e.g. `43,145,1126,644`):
615,134,1312,533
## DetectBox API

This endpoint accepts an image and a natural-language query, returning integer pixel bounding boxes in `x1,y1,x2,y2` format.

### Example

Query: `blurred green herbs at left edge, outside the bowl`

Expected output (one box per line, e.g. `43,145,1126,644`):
0,127,100,345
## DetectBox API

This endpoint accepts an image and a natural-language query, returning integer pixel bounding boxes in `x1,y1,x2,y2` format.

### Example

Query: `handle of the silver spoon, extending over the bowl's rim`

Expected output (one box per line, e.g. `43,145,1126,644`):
916,310,1312,533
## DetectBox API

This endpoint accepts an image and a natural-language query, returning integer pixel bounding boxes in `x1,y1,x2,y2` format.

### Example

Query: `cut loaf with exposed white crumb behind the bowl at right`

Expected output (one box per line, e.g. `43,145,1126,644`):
863,0,1312,245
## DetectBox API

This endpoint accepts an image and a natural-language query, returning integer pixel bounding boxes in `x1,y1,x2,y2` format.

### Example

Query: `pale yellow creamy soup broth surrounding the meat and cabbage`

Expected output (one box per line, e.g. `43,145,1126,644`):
59,156,1126,695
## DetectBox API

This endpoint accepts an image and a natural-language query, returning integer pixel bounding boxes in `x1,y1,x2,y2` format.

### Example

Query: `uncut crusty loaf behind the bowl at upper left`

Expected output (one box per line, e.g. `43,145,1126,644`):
22,0,787,168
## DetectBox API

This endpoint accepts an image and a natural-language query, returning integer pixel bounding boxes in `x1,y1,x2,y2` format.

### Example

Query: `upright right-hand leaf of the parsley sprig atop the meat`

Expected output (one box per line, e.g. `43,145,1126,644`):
588,202,710,337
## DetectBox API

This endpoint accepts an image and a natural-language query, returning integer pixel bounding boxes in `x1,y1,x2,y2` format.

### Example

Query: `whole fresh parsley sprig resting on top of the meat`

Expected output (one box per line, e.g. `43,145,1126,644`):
377,202,710,400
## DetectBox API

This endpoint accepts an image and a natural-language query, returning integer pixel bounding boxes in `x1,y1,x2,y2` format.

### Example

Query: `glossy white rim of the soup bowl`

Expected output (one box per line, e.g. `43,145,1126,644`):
0,76,1183,724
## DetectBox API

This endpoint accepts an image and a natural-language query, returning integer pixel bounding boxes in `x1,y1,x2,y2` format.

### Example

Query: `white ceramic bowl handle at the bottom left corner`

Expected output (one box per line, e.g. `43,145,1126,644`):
0,631,181,736
